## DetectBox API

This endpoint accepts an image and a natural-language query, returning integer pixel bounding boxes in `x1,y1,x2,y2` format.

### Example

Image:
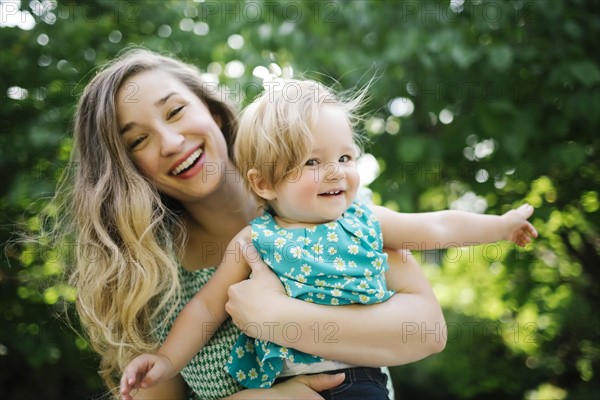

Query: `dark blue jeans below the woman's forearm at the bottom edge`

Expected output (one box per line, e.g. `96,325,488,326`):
278,367,389,400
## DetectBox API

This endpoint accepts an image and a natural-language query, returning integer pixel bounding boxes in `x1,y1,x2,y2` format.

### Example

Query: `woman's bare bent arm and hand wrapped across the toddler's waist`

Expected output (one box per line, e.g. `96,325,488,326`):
226,248,446,367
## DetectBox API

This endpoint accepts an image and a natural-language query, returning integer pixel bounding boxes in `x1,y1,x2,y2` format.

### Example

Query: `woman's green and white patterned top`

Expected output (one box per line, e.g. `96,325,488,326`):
160,267,243,400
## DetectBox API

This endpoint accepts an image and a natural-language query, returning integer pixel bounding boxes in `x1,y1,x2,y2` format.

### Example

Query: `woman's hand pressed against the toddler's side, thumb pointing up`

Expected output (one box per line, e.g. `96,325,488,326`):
225,239,289,337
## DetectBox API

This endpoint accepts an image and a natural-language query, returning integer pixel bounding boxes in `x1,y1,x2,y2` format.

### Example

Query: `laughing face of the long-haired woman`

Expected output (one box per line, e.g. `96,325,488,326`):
116,70,233,202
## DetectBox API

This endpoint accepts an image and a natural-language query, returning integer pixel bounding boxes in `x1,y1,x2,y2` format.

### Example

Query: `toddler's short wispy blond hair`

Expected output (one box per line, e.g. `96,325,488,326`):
233,79,366,206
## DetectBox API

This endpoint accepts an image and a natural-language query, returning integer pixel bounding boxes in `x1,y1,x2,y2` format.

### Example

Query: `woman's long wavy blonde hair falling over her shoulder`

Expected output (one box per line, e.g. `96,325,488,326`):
50,49,237,393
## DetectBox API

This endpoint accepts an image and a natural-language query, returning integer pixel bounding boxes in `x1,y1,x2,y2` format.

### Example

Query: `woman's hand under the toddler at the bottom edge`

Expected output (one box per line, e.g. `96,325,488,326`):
228,373,344,400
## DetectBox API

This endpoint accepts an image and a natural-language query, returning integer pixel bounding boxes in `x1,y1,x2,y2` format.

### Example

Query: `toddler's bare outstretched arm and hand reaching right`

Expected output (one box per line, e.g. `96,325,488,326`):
372,204,537,250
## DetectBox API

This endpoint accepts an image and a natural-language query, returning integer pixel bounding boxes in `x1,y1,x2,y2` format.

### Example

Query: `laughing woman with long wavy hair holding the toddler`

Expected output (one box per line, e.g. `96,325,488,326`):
52,50,445,399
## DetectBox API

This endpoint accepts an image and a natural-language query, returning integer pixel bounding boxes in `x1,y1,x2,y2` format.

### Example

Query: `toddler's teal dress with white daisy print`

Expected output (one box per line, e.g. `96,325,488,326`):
225,202,394,388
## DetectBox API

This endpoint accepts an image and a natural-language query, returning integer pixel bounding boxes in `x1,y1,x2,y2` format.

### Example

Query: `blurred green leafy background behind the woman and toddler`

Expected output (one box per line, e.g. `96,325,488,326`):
0,0,600,399
